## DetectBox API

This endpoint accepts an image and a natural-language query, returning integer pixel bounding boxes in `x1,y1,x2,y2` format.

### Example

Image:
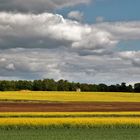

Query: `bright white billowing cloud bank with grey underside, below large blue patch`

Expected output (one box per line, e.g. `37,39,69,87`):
0,12,140,50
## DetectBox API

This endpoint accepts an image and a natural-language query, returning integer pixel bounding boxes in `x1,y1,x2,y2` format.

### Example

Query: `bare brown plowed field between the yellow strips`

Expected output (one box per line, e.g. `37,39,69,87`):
0,102,140,112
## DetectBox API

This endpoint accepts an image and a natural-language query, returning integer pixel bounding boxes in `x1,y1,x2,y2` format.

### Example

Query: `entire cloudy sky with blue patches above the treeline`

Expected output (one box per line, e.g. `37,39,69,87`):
0,0,140,84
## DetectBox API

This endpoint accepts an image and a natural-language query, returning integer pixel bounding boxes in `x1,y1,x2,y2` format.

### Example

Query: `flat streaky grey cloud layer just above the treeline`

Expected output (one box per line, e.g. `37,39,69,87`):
0,48,140,84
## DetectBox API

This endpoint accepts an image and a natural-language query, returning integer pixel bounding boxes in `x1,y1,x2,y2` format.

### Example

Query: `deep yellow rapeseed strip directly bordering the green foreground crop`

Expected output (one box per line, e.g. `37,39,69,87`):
0,117,140,126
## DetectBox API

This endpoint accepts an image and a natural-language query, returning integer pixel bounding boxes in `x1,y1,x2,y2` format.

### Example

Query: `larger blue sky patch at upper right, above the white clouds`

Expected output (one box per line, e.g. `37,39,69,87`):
57,0,140,24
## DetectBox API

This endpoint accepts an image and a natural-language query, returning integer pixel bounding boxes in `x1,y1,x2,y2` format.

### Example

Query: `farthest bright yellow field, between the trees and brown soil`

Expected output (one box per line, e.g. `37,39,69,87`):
0,91,140,102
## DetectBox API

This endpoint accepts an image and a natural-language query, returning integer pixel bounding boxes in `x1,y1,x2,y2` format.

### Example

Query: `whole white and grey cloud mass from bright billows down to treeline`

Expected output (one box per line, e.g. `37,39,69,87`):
0,12,140,83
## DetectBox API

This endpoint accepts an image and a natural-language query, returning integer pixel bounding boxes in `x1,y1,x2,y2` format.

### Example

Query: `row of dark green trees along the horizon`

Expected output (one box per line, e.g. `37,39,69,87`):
0,79,140,92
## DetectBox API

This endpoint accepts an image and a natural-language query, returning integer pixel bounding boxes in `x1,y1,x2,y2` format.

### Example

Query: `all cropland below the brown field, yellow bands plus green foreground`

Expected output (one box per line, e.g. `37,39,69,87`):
0,112,140,140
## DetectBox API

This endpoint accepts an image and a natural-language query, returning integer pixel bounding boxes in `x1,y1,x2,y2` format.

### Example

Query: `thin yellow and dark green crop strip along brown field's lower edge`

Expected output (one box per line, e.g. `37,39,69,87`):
0,112,140,118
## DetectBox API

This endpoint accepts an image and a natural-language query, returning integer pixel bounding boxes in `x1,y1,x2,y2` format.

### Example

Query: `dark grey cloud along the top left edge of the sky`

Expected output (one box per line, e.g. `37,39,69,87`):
0,0,90,13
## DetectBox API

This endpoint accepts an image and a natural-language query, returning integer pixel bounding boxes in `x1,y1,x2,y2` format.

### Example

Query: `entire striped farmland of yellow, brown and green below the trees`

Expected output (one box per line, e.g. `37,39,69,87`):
0,91,140,140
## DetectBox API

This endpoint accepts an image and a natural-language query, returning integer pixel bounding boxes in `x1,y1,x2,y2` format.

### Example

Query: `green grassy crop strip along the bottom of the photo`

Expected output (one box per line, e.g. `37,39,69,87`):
0,128,140,140
